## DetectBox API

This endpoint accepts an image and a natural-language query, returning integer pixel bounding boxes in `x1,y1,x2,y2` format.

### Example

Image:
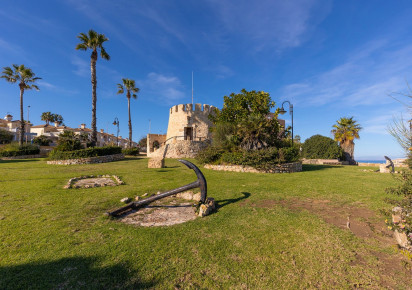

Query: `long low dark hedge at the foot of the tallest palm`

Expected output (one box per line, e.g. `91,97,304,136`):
49,146,122,160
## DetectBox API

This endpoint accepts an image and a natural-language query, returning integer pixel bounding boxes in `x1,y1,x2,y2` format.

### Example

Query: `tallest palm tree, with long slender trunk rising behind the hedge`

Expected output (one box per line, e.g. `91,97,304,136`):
76,29,110,146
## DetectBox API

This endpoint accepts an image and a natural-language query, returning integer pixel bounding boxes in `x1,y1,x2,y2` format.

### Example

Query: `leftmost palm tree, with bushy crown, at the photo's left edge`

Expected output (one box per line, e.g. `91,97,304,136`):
1,64,41,146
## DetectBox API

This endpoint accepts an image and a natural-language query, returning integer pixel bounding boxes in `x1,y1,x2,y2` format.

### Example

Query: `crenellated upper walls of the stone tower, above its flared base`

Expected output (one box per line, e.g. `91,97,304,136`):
166,104,214,143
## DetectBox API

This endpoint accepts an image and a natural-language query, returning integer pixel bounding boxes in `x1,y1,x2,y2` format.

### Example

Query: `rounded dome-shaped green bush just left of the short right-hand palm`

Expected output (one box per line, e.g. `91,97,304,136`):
302,135,344,159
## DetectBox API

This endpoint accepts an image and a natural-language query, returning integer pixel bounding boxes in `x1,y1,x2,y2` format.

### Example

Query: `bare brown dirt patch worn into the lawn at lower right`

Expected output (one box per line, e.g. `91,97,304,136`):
243,199,412,288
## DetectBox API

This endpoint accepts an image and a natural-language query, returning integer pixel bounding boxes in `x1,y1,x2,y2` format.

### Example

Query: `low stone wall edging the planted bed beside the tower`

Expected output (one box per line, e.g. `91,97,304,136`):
204,162,302,173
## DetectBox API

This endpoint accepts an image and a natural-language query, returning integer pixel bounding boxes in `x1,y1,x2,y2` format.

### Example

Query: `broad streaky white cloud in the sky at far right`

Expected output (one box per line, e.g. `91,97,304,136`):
283,41,412,107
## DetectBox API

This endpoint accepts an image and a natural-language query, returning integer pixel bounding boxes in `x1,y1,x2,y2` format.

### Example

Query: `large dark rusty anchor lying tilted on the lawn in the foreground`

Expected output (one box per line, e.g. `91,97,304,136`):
106,159,207,217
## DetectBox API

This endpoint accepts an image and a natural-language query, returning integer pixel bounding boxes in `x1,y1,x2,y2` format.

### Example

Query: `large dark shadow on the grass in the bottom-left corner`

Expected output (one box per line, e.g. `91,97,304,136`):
0,257,155,289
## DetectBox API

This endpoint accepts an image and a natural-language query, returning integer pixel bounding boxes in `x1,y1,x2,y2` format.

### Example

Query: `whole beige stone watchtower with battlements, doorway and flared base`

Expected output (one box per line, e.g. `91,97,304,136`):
147,104,214,158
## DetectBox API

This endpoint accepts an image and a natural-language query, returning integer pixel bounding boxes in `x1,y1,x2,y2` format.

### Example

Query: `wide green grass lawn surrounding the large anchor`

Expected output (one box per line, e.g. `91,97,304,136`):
0,158,412,289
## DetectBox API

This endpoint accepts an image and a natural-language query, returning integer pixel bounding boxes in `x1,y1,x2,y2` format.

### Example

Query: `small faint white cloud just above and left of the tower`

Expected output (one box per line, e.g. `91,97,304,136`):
136,72,185,105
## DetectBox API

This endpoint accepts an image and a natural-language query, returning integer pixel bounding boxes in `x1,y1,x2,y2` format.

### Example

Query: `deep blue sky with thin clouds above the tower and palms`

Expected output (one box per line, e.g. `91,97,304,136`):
0,0,412,159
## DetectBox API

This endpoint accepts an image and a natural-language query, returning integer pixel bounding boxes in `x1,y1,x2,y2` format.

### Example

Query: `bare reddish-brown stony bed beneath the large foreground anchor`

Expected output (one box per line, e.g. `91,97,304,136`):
119,198,196,227
